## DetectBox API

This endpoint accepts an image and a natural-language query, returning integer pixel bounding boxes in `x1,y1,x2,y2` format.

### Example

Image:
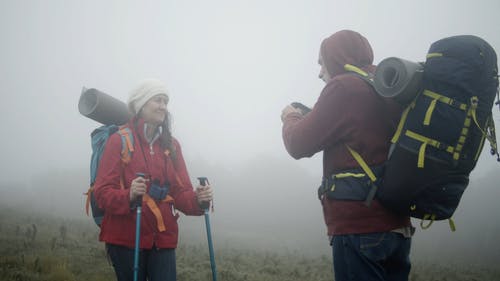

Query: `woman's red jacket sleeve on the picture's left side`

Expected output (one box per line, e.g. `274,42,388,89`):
94,134,130,214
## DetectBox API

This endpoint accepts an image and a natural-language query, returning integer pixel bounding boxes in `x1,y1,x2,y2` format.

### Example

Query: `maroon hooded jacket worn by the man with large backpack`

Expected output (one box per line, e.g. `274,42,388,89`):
283,32,410,235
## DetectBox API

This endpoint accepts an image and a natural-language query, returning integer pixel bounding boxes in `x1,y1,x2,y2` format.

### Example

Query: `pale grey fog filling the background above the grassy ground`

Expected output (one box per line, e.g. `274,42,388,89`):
0,0,500,265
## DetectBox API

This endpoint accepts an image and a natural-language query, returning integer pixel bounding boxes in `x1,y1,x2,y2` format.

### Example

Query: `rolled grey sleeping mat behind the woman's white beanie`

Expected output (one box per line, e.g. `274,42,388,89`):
78,88,132,125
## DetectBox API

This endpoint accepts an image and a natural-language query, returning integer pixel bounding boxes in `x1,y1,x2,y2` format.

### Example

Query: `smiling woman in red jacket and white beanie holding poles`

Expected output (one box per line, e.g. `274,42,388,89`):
94,79,212,281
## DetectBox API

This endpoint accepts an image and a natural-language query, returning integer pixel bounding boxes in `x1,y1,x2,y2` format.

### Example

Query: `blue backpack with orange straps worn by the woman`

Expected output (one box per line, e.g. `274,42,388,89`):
85,125,134,227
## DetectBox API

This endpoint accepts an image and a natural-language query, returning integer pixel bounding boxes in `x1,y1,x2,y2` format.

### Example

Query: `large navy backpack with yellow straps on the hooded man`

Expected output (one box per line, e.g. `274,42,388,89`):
328,35,500,230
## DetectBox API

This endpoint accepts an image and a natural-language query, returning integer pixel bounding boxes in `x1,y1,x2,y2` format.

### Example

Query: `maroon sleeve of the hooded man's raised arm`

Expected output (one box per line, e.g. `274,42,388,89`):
282,80,355,159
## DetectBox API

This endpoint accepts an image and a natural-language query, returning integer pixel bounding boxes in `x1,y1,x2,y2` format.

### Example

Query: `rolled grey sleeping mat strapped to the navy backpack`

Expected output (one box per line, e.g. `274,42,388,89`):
373,57,424,105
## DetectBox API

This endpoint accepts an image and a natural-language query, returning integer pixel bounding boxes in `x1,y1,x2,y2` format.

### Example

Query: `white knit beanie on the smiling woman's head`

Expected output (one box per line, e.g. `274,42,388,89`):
127,78,168,115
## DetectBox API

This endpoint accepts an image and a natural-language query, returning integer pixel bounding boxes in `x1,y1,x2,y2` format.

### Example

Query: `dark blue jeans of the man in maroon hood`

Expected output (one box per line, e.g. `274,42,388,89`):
332,232,411,281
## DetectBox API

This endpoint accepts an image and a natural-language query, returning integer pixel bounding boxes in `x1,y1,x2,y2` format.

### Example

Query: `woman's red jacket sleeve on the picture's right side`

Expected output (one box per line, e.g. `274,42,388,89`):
170,139,203,216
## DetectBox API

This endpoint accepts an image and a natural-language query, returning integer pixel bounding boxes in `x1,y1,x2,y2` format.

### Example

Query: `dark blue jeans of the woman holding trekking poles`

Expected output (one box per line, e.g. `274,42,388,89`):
106,244,177,281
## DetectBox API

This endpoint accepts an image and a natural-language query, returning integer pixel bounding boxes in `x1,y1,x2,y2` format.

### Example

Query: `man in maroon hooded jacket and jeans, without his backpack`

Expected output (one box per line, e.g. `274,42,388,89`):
281,30,413,281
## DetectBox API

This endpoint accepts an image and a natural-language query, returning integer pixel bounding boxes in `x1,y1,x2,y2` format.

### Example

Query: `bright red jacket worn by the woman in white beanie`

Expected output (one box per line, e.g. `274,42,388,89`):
94,117,203,249
